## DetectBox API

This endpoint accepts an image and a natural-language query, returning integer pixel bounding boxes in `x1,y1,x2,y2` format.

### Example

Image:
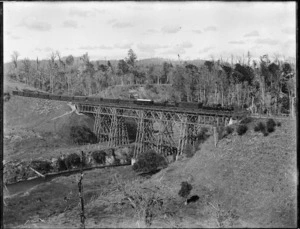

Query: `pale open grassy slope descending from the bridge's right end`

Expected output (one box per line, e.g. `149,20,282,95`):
149,121,297,227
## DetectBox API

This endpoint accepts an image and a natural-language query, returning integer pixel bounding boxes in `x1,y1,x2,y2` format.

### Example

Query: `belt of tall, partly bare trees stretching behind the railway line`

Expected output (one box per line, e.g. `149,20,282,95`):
4,49,296,116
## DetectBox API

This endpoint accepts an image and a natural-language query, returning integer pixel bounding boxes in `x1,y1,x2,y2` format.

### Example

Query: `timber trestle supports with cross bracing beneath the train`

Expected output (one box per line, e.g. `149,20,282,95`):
77,104,230,157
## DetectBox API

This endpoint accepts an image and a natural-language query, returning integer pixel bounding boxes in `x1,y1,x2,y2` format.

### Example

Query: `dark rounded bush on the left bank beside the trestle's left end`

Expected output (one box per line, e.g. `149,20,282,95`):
70,126,97,145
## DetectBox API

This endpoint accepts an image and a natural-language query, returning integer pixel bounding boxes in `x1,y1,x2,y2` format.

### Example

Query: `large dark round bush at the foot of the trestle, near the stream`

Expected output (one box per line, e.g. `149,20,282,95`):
133,150,168,173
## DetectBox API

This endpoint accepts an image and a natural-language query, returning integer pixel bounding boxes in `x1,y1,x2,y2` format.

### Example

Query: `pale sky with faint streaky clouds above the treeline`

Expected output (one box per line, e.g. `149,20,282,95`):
3,1,296,62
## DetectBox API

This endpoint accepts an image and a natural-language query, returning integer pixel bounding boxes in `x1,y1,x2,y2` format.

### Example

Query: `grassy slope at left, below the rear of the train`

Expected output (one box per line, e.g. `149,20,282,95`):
4,78,93,160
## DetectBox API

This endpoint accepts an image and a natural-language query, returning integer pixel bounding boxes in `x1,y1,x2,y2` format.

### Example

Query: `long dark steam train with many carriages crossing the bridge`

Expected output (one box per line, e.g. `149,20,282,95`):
12,89,235,112
